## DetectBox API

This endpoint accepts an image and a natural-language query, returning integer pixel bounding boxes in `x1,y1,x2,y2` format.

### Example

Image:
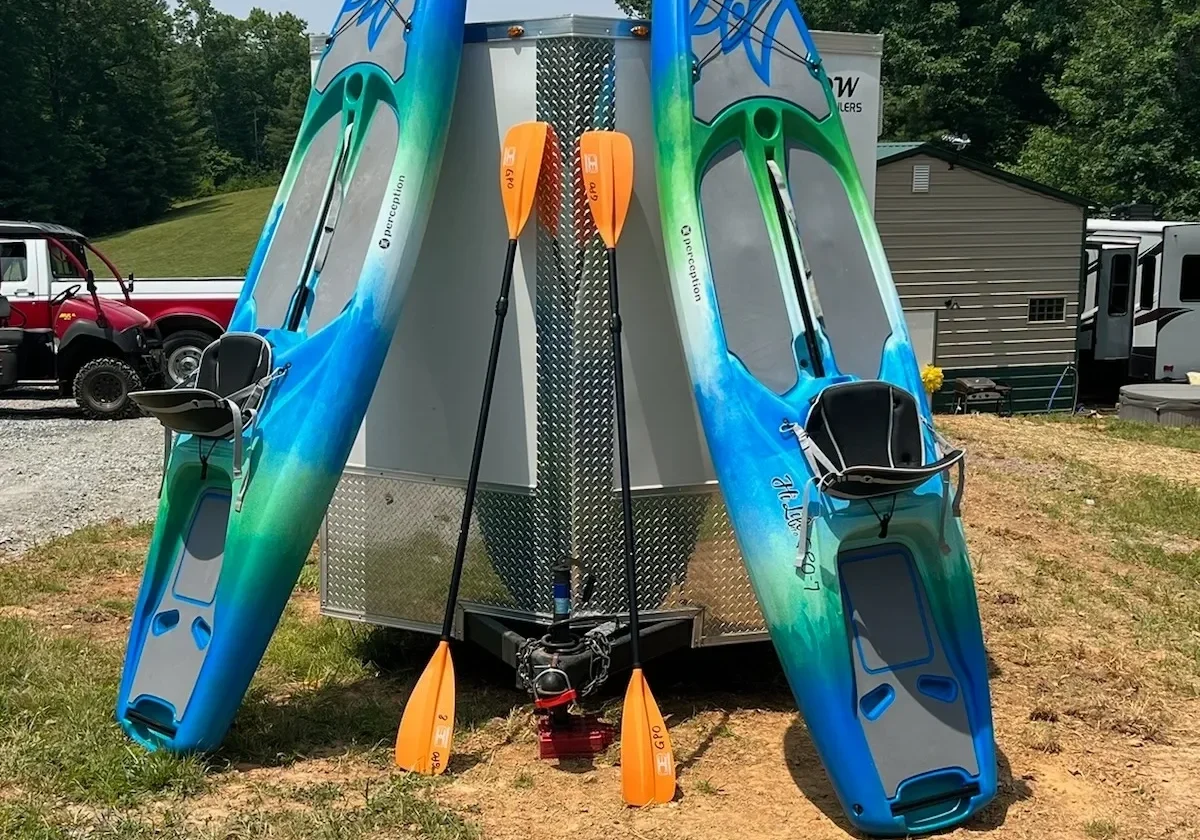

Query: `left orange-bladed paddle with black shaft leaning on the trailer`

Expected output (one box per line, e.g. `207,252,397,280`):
396,121,550,774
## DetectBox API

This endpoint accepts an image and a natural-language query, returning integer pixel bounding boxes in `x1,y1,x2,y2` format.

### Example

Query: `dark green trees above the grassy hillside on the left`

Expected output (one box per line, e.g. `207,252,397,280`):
0,0,310,235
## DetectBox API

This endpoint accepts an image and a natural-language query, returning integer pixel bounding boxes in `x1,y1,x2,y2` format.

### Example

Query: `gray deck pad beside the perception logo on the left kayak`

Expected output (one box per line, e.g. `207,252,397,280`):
307,104,406,335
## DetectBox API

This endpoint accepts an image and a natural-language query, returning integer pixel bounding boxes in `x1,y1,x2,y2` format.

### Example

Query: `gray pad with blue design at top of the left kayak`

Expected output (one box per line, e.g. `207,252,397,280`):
314,0,416,94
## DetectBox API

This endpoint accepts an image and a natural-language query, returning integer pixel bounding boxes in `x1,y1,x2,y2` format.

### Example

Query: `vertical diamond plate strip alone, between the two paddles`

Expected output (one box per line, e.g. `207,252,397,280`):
535,38,624,612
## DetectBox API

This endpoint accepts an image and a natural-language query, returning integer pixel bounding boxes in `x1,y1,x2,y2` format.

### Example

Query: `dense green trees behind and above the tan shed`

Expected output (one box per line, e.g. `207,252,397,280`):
618,0,1200,218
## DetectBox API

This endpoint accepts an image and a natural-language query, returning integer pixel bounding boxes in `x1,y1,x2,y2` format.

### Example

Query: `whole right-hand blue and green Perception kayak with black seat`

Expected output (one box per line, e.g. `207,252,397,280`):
652,0,996,836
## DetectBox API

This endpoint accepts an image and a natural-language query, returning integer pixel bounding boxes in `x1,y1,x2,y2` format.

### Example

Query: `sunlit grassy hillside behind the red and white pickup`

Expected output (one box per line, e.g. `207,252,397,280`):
96,187,275,277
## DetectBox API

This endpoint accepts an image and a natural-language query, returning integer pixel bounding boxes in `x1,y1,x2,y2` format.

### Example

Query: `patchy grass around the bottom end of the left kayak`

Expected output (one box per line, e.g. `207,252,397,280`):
0,524,477,840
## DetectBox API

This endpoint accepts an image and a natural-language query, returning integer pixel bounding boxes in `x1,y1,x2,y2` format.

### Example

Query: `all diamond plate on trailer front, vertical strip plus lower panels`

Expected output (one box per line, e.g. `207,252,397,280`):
322,27,764,643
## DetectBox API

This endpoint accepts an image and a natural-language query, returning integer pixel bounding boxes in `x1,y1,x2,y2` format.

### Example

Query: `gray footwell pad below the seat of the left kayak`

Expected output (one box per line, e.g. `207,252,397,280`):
130,490,230,720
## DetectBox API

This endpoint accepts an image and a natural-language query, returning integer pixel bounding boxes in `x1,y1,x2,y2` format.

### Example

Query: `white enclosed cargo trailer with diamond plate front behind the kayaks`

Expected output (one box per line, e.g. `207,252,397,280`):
314,16,883,652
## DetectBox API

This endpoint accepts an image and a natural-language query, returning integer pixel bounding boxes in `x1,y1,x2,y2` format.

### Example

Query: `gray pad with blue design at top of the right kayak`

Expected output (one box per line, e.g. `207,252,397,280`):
691,0,829,122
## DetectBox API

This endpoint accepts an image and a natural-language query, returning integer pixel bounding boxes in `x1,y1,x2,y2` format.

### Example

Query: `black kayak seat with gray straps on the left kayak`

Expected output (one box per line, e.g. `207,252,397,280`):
130,332,287,510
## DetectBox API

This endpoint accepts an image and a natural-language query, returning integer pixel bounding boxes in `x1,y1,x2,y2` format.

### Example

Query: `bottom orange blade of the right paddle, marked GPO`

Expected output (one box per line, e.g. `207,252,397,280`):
620,668,676,806
